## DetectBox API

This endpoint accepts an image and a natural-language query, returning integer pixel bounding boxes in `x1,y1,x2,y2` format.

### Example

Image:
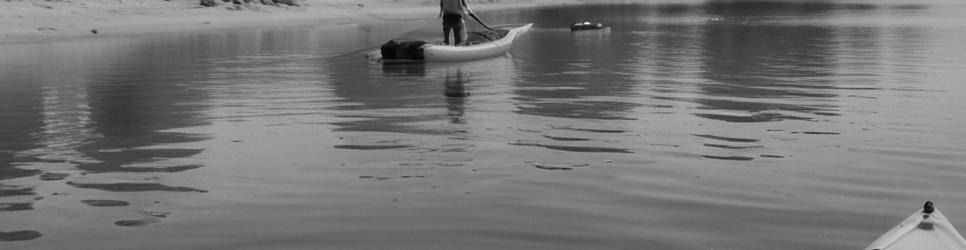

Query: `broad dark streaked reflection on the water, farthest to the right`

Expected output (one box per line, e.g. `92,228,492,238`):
693,7,839,161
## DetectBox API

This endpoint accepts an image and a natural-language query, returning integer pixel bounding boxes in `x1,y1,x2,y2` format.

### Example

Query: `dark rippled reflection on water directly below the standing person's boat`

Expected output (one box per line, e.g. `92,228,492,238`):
328,57,517,135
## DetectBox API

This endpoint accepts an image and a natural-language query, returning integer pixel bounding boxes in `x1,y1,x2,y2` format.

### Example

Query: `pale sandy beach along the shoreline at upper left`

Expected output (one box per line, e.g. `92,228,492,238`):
0,0,602,42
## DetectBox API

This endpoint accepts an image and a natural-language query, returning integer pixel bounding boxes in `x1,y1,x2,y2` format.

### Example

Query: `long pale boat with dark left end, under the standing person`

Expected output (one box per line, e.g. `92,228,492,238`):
370,23,533,62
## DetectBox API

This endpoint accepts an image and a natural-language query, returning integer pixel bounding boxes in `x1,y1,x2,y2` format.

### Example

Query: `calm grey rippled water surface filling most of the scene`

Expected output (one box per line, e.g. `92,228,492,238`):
0,3,966,249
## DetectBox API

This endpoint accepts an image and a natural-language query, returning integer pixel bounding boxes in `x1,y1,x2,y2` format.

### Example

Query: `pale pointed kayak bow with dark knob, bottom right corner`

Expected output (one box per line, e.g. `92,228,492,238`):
866,202,966,250
